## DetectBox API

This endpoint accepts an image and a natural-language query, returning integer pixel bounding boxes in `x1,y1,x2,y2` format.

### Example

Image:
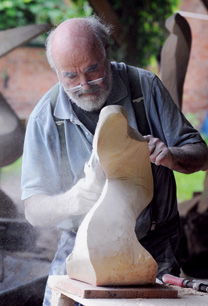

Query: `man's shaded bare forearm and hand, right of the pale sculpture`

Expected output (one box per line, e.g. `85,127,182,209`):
144,135,208,174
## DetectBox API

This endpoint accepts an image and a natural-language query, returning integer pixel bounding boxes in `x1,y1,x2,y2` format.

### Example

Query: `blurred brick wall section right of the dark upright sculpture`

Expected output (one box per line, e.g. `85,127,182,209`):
180,0,208,122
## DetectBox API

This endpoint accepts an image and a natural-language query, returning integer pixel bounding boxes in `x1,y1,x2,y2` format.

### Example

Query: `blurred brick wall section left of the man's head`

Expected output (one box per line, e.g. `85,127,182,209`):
0,47,57,119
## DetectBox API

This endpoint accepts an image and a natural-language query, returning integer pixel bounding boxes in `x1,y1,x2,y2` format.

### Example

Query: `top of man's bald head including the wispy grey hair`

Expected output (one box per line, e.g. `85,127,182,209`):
46,17,111,69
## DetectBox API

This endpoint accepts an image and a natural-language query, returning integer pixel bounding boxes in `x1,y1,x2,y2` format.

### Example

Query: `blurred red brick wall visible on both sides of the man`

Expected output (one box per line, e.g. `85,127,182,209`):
0,0,208,122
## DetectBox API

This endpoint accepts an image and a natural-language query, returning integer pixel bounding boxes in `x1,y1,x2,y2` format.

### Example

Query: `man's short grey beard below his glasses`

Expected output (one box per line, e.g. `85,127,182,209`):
64,71,112,112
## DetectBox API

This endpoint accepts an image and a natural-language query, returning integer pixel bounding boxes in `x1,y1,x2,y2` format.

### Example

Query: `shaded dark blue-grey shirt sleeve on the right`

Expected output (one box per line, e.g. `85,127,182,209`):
141,74,203,147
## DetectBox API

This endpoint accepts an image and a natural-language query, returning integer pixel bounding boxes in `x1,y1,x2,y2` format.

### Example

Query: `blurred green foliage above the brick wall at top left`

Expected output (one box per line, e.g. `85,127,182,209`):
0,0,92,30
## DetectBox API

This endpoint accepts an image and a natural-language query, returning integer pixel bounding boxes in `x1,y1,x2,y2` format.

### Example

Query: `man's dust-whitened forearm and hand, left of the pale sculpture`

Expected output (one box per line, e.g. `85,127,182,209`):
24,172,103,227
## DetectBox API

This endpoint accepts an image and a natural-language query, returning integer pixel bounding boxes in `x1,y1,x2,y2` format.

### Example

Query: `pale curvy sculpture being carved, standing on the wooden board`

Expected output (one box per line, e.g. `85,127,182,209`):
66,106,157,286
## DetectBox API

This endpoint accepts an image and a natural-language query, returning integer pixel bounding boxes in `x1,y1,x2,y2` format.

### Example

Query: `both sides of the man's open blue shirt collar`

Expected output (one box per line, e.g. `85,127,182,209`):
54,65,128,121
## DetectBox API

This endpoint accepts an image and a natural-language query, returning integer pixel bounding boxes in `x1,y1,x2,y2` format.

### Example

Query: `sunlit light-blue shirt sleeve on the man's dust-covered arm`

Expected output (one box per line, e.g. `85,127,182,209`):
21,104,61,200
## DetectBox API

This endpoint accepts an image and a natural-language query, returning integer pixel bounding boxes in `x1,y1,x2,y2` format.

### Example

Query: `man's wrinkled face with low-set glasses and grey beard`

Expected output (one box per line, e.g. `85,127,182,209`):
52,34,112,111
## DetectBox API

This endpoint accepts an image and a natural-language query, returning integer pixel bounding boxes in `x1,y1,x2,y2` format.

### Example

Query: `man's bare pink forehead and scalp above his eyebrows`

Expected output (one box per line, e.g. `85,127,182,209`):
52,19,104,75
